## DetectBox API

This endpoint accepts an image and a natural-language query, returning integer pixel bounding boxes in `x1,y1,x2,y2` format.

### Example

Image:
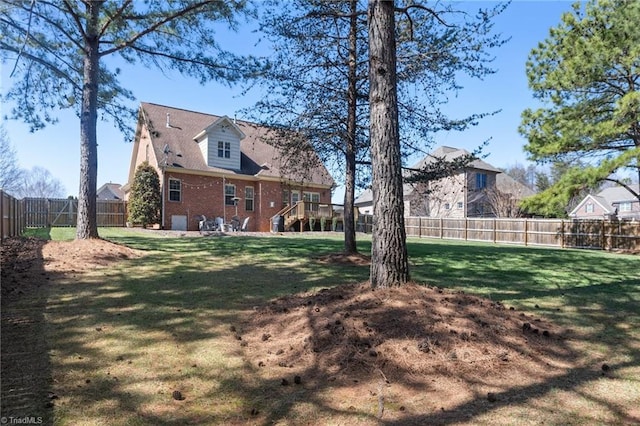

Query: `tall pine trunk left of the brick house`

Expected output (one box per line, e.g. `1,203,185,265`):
76,2,101,240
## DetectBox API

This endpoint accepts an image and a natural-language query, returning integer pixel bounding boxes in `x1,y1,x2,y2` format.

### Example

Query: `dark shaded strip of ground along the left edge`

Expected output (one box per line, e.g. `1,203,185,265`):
0,238,56,424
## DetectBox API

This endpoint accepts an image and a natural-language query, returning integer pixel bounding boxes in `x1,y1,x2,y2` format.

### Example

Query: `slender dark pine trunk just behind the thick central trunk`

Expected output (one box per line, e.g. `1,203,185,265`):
344,0,358,254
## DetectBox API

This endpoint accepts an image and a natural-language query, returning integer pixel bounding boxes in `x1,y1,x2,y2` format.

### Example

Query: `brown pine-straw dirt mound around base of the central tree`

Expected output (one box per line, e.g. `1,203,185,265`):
240,284,573,418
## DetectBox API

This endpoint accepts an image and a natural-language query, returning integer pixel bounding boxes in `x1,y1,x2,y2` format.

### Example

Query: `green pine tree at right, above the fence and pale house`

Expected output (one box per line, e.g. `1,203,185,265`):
520,0,640,212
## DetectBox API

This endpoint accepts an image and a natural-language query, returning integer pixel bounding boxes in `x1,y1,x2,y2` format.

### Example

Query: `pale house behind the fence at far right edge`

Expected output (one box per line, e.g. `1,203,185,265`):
569,184,640,220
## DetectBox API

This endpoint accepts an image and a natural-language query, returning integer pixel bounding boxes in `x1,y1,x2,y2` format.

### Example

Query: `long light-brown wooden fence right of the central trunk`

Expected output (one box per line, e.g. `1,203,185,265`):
356,215,640,250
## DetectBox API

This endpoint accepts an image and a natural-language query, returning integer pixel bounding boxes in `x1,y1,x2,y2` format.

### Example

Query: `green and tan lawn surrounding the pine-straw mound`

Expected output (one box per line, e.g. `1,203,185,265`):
21,228,640,425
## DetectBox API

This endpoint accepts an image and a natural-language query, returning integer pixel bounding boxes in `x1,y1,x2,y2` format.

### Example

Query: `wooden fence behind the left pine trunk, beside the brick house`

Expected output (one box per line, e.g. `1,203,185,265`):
22,198,127,228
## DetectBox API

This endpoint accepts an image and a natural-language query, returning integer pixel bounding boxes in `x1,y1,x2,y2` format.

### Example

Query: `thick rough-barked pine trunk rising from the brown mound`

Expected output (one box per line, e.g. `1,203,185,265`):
368,0,409,288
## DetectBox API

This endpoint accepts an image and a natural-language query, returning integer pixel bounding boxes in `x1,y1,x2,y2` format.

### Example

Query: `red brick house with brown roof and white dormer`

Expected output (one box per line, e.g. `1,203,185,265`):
124,103,334,231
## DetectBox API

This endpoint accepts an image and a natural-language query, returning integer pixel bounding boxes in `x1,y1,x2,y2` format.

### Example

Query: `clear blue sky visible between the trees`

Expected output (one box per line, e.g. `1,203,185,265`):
0,0,572,202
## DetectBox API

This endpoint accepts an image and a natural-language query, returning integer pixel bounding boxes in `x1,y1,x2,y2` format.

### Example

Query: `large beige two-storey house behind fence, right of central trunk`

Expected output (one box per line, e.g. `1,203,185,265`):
355,146,533,218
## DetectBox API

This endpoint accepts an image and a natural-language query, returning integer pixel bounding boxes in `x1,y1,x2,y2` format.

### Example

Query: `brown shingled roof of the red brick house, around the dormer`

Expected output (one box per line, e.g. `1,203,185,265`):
140,102,334,186
